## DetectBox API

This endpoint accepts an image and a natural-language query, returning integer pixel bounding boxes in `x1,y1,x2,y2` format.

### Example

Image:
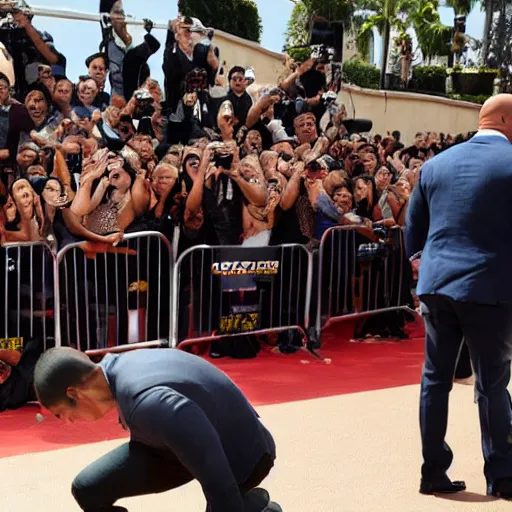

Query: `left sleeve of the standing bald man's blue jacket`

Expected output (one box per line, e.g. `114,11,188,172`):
405,170,430,258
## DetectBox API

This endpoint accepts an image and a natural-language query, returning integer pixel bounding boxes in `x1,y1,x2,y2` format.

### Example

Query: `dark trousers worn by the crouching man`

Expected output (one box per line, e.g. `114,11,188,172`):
72,441,274,512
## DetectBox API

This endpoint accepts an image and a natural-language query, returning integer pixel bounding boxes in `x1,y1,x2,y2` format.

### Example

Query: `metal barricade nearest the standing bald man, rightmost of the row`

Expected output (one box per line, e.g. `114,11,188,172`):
316,226,414,335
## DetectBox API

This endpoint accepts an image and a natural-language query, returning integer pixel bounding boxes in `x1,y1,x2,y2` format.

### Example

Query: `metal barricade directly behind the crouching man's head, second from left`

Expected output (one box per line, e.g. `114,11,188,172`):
55,231,173,355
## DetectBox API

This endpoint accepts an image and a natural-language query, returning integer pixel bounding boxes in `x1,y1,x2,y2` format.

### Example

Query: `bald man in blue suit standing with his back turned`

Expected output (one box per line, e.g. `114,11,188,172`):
406,94,512,498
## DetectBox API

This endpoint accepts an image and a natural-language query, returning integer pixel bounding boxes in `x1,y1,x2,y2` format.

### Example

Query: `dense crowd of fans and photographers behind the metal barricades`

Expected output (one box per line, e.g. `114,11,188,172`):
0,2,476,251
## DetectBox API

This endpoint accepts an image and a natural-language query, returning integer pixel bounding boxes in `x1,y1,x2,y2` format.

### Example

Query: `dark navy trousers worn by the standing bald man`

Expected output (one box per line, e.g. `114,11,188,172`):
420,295,512,488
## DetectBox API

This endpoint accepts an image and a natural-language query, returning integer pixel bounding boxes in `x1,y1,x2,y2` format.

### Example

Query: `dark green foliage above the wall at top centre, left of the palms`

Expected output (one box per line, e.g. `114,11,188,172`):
178,0,263,43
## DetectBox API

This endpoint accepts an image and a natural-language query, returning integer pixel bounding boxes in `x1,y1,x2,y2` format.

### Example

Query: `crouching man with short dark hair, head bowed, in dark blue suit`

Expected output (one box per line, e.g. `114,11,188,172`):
34,347,281,512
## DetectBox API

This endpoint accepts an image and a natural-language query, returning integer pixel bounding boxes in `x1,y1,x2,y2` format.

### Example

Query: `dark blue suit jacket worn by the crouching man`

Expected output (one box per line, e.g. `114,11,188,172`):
100,349,275,512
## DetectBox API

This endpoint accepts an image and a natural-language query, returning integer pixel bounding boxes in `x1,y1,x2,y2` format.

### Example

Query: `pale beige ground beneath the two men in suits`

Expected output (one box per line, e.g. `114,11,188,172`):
0,386,512,512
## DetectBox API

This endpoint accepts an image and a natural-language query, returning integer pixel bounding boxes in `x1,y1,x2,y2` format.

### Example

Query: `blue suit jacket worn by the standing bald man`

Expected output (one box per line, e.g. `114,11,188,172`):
405,136,512,304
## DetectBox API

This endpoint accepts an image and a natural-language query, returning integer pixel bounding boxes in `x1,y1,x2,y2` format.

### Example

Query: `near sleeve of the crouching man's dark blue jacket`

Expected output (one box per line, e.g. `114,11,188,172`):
128,387,244,512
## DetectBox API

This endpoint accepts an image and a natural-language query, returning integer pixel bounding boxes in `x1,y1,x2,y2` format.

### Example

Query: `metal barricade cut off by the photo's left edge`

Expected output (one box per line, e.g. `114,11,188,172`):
0,242,55,350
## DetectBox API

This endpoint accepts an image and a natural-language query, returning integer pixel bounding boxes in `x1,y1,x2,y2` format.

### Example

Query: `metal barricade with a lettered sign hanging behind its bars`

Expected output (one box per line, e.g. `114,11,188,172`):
171,244,312,348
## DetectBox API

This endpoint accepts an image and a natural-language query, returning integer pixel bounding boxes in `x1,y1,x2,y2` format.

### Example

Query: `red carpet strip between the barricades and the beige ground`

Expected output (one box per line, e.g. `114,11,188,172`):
0,323,423,457
